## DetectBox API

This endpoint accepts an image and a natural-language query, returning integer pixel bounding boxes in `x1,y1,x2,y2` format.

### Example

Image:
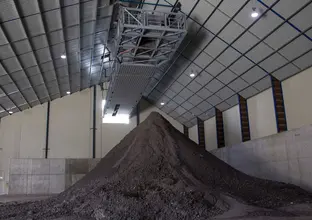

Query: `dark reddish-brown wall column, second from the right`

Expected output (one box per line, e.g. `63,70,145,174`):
238,95,250,142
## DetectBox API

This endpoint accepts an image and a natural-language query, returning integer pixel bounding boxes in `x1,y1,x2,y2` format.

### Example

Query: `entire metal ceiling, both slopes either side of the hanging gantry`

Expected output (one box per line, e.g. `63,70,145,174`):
0,0,312,126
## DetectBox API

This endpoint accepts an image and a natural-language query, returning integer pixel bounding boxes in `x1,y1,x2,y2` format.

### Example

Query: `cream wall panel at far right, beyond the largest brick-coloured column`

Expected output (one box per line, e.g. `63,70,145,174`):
282,68,312,129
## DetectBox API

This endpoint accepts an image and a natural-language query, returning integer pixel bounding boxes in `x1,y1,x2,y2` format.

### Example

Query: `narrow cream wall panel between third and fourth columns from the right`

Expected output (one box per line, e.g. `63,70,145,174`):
204,117,218,151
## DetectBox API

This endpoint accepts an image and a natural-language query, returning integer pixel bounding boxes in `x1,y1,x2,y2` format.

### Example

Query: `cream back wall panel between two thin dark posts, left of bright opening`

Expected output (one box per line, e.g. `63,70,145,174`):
49,89,93,158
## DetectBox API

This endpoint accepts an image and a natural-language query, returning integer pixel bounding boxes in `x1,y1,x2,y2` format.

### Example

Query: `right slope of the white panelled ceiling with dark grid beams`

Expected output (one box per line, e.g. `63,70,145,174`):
142,0,312,127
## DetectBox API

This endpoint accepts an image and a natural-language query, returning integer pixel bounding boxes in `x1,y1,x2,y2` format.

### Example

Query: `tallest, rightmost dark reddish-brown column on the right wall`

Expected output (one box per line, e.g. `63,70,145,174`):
271,76,287,132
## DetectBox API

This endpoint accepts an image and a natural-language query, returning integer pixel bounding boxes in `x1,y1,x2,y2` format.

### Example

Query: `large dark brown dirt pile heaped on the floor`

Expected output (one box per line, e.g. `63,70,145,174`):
0,113,312,220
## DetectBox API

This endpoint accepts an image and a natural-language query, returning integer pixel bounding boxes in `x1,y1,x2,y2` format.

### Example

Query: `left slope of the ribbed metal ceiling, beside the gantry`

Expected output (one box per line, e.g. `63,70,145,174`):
0,0,111,117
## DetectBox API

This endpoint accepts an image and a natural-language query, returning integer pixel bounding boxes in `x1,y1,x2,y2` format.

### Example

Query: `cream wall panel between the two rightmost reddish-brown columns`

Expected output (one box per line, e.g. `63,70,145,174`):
247,89,277,139
